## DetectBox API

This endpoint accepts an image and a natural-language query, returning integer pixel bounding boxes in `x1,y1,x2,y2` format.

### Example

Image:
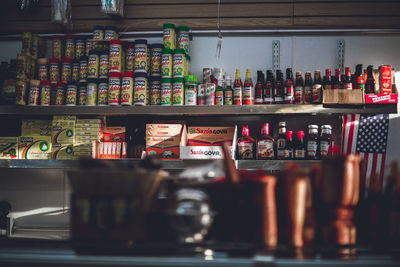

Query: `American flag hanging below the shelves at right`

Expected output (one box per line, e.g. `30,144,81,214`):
342,114,389,191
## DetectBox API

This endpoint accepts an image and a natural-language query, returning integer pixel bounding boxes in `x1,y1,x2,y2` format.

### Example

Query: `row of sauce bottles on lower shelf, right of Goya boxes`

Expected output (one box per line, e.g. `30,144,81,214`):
238,121,335,160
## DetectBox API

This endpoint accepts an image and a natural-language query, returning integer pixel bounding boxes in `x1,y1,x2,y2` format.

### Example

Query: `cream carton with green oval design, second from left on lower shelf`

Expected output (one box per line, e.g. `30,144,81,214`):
18,136,51,159
